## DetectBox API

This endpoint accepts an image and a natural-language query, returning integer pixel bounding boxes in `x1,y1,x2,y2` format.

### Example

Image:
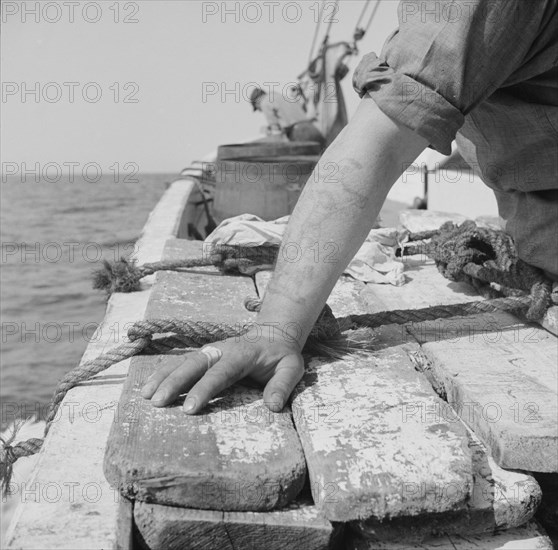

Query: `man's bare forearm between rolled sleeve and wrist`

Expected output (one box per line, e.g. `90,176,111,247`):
258,98,428,345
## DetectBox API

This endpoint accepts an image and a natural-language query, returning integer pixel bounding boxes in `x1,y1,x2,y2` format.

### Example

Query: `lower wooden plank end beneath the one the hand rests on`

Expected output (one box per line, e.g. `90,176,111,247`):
134,498,341,550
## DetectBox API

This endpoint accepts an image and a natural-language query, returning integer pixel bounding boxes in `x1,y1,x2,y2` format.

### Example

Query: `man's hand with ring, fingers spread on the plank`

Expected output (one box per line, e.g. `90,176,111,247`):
141,333,304,414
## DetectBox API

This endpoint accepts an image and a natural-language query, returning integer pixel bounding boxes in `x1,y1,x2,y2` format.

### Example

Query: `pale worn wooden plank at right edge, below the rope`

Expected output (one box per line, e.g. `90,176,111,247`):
409,313,558,472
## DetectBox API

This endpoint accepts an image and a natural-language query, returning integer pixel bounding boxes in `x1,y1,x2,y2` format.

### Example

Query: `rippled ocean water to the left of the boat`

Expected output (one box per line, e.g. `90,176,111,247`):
0,174,174,428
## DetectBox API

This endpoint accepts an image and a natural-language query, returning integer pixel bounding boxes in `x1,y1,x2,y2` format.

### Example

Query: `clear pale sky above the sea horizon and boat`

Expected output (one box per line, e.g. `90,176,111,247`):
0,0,398,173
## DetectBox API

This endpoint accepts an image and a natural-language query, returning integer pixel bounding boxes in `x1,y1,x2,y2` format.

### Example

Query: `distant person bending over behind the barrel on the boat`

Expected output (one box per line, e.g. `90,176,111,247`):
250,88,325,145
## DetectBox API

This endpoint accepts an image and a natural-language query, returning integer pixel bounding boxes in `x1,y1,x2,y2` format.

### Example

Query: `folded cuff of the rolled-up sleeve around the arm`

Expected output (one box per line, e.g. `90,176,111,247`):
353,54,465,155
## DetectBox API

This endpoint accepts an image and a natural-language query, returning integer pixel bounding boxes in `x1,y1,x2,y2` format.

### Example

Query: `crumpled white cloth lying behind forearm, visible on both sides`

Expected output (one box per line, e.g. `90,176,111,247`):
204,214,405,286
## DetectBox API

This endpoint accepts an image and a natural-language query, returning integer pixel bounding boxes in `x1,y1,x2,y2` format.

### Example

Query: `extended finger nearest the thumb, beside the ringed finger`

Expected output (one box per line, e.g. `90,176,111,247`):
184,356,251,414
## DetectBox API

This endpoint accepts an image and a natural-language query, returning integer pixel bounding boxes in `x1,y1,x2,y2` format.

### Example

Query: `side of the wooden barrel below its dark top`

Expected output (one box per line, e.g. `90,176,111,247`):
213,155,319,223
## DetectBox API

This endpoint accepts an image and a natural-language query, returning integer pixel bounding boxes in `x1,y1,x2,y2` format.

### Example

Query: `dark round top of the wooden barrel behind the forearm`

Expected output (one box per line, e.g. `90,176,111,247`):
217,141,321,160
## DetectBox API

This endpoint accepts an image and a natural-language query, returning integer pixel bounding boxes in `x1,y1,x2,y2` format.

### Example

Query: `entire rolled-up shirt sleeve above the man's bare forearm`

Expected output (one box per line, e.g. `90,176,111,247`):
353,0,549,155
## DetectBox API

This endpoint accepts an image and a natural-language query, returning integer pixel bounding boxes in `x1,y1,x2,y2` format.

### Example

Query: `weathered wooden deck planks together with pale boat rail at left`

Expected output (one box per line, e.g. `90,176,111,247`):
6,183,558,550
